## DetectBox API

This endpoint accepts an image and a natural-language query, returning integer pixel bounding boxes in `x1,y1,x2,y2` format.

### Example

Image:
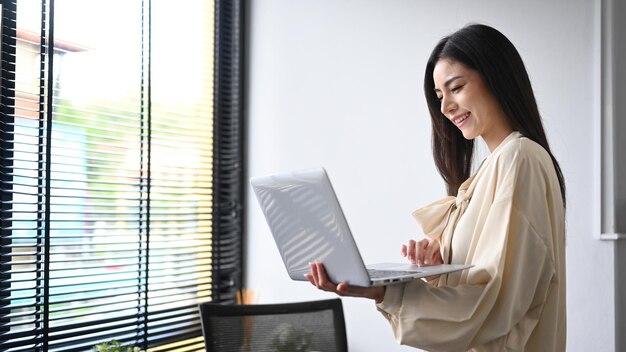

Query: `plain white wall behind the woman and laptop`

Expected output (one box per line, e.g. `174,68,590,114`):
246,0,615,351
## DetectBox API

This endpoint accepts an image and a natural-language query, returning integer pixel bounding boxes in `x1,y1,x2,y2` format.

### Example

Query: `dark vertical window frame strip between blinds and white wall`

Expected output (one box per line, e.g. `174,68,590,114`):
213,0,246,304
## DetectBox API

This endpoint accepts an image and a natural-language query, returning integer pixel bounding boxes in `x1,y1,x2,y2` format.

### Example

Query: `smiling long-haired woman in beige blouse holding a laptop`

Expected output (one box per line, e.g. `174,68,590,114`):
306,25,566,351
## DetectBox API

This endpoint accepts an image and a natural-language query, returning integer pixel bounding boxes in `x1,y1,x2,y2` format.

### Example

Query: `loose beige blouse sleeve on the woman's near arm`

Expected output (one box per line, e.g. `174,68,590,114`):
377,143,554,351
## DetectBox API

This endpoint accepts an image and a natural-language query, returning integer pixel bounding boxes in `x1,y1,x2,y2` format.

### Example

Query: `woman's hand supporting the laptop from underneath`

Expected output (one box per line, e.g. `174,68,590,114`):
304,262,385,303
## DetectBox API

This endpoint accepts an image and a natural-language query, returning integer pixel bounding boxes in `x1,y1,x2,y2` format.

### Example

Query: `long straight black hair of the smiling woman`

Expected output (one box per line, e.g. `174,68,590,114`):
424,24,565,205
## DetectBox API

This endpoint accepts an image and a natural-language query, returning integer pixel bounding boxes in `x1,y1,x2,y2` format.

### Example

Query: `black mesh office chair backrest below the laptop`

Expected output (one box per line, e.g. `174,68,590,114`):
199,298,348,352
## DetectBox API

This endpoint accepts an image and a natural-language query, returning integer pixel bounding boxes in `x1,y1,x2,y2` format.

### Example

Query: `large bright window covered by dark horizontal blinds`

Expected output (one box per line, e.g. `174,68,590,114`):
0,0,243,351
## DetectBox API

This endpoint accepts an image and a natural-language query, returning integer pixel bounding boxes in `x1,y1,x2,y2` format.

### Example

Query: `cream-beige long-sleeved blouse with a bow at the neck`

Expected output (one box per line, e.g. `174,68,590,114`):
377,132,566,352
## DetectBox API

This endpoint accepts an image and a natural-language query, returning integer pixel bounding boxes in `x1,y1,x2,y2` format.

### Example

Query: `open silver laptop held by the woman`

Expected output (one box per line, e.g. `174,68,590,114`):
250,168,471,287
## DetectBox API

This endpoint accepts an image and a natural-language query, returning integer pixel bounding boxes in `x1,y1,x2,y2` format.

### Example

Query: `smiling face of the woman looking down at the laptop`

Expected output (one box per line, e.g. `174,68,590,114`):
433,59,513,151
